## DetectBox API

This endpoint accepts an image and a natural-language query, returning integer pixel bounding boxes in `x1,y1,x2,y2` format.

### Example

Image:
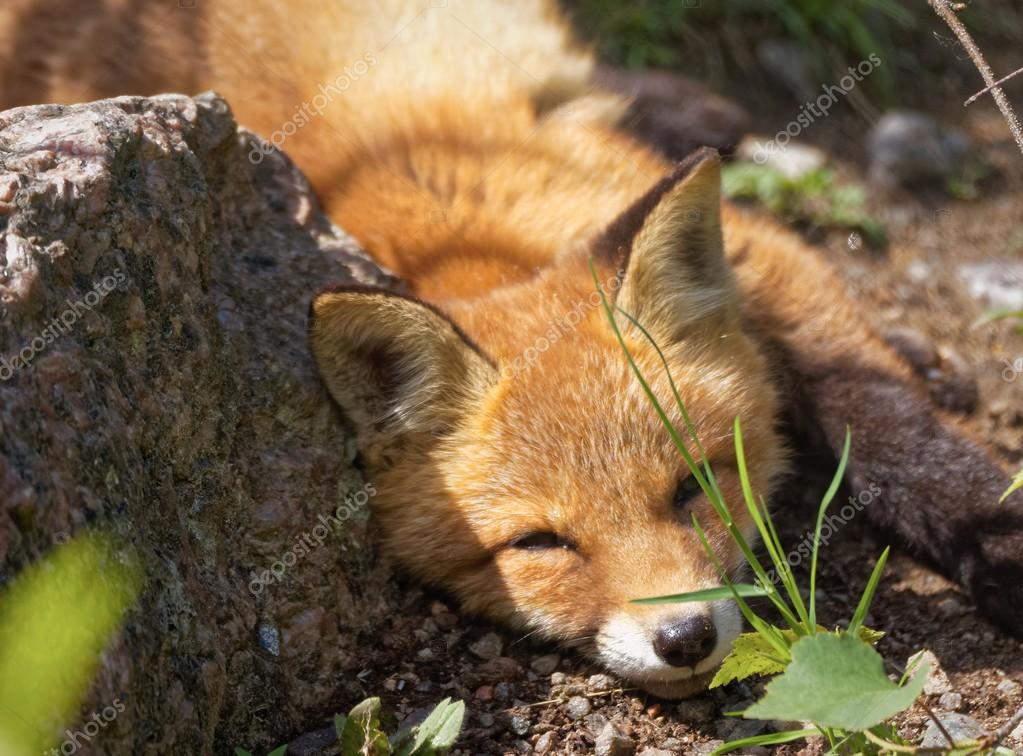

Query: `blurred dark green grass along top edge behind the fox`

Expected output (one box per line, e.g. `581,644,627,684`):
569,0,926,97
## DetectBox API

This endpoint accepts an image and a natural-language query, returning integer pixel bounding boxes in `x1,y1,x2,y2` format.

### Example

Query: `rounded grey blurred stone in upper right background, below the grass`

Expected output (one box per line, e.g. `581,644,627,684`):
866,110,972,188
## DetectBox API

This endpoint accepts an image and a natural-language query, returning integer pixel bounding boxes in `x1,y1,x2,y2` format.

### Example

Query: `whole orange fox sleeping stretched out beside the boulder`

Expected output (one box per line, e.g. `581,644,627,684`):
0,0,1023,697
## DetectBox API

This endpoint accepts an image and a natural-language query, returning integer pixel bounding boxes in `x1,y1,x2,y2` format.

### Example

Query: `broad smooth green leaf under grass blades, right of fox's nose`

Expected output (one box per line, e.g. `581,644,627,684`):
743,633,929,731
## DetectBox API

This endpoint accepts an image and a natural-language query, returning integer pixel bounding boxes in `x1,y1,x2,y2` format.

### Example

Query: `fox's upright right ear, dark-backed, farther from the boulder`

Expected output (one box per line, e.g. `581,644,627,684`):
598,149,738,344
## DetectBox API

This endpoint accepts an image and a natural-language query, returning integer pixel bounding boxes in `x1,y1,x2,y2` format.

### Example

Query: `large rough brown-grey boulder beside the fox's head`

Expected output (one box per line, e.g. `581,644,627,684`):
0,94,397,756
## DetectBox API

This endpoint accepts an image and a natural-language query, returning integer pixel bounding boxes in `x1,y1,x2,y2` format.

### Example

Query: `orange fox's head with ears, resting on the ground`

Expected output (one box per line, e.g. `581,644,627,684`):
311,152,784,697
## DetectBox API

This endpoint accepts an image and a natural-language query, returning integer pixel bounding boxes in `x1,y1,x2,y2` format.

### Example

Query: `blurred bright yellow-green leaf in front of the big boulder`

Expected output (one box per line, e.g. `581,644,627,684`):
0,534,141,756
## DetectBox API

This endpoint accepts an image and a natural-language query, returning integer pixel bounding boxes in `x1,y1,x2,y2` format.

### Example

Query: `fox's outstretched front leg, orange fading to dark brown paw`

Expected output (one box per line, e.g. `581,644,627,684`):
725,208,1023,635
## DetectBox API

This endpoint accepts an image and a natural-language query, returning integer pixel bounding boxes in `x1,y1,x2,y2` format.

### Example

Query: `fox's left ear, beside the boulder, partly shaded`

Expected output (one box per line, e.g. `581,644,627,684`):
310,287,496,441
